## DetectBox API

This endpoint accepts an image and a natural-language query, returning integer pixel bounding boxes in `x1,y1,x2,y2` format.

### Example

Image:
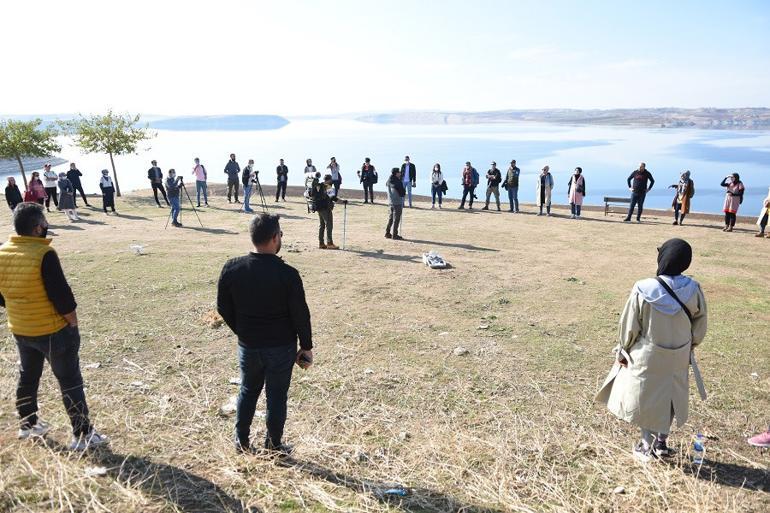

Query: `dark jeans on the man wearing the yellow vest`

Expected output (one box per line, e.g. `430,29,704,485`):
14,326,91,436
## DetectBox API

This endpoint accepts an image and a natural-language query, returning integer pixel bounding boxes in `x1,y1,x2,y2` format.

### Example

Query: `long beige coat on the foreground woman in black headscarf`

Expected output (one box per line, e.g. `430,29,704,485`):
596,276,707,433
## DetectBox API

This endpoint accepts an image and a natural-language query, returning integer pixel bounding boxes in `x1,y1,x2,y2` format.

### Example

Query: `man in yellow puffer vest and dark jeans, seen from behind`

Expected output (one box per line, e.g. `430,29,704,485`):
0,203,107,451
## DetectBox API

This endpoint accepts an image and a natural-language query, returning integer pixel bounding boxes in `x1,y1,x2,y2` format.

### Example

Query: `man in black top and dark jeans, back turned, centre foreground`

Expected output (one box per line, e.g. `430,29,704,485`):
217,214,313,454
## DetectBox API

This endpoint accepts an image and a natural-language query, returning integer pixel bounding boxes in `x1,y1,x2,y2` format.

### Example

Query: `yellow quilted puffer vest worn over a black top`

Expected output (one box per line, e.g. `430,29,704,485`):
0,235,67,337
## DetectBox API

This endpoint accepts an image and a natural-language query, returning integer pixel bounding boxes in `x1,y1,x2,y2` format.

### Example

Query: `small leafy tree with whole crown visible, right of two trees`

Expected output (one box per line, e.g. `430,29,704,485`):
62,110,153,196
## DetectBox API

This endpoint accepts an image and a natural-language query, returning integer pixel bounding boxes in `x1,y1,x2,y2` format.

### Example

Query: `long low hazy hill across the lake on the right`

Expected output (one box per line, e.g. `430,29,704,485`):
356,108,770,130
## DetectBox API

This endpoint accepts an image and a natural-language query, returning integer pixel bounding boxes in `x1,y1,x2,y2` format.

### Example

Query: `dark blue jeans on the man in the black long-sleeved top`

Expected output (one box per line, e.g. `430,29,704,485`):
235,344,297,448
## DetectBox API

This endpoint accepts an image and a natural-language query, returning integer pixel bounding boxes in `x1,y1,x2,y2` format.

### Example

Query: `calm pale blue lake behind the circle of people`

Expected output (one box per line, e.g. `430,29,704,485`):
25,120,770,215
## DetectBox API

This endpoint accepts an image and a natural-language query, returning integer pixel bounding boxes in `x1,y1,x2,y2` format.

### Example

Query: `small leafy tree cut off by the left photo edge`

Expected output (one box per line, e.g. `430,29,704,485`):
0,119,61,188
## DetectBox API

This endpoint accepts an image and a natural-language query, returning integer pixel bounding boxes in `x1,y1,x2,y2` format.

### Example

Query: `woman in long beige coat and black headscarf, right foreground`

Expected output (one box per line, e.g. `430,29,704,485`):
597,239,707,462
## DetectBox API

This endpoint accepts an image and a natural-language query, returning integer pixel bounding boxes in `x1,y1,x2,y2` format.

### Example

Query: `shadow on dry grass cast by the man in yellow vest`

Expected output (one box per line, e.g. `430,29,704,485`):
46,440,262,513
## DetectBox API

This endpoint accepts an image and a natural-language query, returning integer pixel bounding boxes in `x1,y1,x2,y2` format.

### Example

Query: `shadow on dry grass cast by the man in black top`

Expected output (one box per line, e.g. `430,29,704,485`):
277,458,502,513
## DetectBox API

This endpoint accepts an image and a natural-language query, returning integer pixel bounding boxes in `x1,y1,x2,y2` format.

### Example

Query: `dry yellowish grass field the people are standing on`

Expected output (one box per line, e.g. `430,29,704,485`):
0,186,770,513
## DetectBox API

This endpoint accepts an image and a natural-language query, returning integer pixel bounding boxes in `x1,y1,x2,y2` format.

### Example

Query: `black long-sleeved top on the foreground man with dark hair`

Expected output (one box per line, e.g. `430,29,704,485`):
217,253,313,349
